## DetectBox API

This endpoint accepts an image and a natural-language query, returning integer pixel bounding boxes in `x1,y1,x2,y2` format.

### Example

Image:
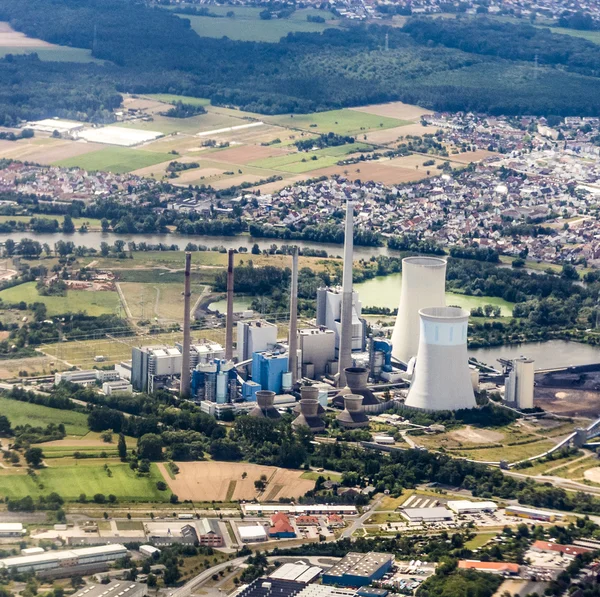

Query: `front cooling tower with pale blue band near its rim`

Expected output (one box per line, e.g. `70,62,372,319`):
405,307,476,410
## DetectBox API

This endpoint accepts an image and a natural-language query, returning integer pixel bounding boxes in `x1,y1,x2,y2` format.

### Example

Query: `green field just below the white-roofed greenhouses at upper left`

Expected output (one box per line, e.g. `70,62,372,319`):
53,147,173,174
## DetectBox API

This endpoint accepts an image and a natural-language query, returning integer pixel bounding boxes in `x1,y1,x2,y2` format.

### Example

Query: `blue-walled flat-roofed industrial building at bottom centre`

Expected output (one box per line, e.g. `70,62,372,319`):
322,551,394,587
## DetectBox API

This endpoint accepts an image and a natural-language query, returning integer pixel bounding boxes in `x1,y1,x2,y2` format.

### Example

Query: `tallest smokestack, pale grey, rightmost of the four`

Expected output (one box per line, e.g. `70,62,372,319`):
338,201,354,388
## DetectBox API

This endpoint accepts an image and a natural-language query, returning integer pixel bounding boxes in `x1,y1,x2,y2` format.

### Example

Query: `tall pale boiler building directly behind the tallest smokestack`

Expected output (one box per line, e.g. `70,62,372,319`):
317,286,367,354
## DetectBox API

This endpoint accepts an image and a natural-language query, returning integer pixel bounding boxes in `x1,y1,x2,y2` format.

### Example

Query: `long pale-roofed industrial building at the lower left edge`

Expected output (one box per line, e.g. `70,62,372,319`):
0,544,129,576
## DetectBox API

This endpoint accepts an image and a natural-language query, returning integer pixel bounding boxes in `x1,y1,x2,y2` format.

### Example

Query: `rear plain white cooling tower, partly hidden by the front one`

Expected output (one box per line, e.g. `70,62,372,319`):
392,257,446,363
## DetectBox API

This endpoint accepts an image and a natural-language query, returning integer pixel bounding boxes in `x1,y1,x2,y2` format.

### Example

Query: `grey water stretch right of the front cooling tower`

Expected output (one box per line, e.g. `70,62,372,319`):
469,340,600,369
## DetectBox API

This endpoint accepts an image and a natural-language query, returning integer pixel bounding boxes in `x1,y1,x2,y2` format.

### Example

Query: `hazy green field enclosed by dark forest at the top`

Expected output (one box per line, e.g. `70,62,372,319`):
177,6,335,42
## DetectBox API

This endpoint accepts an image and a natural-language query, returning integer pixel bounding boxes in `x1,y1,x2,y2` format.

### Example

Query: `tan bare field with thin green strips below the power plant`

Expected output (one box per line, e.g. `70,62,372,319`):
159,462,315,502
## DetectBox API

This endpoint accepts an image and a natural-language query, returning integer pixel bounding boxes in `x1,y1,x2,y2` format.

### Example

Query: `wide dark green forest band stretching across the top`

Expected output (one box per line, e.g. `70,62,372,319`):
0,0,600,125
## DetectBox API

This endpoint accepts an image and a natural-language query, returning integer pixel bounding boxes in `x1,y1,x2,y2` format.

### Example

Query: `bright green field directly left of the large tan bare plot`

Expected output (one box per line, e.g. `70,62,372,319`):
0,461,170,502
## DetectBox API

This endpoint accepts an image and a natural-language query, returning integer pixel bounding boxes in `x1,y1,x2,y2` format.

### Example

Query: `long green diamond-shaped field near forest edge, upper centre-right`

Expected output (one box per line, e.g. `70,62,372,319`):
264,109,412,135
